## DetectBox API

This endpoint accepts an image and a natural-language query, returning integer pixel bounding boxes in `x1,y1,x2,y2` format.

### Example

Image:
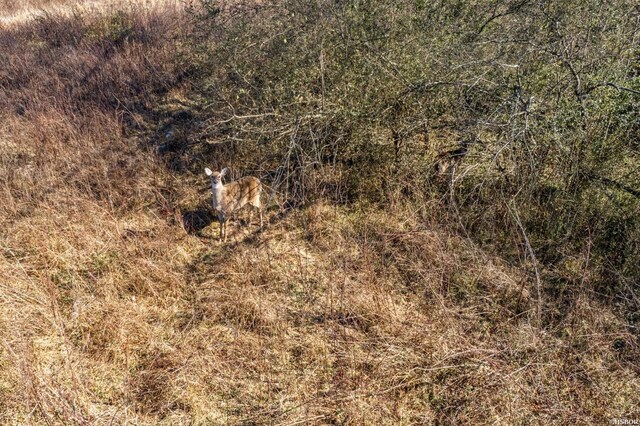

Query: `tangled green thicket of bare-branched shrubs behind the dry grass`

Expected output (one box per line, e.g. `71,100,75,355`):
190,0,640,324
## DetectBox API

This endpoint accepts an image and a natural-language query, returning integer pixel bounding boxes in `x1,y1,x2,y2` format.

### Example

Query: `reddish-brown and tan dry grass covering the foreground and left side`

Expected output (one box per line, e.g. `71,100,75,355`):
0,1,640,425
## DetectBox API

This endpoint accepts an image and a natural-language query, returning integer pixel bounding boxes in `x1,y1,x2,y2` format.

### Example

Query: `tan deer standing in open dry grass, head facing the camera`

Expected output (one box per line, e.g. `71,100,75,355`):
204,167,263,242
